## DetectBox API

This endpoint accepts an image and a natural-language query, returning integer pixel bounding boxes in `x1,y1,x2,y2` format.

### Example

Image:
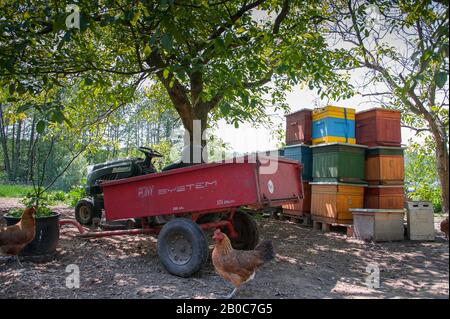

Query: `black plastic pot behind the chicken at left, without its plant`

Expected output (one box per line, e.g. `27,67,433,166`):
3,212,60,256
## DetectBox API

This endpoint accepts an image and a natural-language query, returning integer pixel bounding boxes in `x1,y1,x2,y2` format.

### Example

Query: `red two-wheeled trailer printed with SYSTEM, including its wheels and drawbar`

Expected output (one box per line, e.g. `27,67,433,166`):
63,156,303,277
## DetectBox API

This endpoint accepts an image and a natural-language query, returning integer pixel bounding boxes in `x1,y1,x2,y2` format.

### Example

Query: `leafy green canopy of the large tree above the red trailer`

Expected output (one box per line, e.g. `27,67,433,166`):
0,0,351,140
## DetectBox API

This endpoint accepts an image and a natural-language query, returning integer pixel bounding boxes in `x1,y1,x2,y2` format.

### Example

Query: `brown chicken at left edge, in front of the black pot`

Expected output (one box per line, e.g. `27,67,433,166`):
0,207,36,266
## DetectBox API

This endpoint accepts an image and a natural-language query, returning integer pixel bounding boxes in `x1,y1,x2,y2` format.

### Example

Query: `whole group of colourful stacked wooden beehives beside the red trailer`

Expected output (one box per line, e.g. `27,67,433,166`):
283,106,404,228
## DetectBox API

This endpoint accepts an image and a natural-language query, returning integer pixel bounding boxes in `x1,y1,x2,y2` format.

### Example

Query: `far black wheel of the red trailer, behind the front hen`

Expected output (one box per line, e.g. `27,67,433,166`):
223,210,259,250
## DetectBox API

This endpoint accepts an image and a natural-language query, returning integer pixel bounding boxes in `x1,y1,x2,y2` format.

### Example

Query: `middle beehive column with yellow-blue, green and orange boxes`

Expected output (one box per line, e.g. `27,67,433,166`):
310,106,367,228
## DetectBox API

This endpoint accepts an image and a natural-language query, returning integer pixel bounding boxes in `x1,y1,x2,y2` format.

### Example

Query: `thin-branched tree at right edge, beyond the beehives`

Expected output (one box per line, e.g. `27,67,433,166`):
329,0,449,213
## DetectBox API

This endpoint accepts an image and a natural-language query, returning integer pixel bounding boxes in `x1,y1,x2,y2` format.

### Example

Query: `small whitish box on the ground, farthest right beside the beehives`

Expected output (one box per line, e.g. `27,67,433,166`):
406,202,436,240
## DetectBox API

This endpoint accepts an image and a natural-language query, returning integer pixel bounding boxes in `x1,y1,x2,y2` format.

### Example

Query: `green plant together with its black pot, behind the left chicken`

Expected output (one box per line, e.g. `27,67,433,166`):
4,189,60,257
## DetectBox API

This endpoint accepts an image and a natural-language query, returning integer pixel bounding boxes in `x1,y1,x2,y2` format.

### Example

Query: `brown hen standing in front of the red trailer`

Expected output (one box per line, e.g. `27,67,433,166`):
212,229,275,298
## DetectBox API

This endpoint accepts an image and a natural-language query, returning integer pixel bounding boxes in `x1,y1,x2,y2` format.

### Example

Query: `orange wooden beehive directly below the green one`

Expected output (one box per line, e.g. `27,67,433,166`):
311,182,366,224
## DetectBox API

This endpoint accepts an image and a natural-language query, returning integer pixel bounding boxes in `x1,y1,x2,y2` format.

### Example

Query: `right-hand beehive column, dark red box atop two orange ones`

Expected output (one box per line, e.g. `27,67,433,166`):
356,108,404,209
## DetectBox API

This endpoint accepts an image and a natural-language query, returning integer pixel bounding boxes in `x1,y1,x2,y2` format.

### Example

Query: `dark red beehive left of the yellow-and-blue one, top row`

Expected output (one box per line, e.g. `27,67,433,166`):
286,109,312,145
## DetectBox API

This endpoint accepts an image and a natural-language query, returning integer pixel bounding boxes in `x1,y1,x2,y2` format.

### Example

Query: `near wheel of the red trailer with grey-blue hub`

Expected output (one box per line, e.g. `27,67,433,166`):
158,218,208,277
